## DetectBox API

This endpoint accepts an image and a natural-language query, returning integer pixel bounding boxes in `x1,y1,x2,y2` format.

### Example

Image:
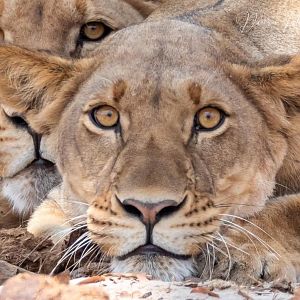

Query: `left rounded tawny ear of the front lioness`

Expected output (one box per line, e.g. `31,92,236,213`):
0,46,91,132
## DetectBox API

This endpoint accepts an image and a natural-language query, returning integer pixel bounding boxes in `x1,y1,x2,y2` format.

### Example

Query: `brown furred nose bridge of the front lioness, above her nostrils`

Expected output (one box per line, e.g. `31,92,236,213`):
117,136,187,203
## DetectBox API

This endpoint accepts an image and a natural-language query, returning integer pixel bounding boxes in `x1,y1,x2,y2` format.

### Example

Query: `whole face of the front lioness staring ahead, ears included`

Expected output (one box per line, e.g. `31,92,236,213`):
0,21,294,280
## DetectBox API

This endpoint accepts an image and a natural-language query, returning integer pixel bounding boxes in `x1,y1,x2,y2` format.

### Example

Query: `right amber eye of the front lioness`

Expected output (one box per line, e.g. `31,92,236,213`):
195,107,225,131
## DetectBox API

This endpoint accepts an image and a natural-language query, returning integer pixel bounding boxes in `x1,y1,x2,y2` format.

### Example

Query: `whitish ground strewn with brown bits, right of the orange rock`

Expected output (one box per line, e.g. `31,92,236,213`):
71,276,300,300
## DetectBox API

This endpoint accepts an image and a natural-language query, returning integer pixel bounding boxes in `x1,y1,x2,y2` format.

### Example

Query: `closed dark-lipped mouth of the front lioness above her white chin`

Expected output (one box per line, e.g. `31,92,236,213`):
118,244,191,260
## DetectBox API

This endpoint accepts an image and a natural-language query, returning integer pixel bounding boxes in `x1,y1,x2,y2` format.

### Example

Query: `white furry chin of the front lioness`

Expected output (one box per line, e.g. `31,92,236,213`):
110,254,198,281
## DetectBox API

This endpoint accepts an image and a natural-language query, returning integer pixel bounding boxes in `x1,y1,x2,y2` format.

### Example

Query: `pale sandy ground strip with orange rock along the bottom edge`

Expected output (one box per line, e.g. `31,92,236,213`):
0,274,300,300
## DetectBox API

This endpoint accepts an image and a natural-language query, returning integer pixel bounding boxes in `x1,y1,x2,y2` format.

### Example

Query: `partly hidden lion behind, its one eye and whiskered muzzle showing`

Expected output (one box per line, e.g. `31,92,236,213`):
0,0,158,216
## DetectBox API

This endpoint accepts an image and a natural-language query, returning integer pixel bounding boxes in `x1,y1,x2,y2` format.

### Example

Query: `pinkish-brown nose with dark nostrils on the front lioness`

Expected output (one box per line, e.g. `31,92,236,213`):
122,199,180,226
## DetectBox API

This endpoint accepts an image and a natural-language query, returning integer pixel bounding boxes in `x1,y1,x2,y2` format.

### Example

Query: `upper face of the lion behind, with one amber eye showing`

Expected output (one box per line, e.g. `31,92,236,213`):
0,0,143,57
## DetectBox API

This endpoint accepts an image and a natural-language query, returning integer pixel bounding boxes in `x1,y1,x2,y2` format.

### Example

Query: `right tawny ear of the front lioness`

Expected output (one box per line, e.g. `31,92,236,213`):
226,55,300,131
